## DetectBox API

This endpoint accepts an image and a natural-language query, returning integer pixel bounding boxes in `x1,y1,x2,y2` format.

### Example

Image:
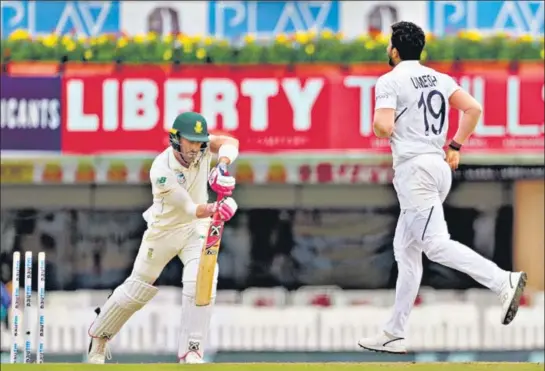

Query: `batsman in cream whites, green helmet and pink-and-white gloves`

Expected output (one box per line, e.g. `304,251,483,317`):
88,112,238,364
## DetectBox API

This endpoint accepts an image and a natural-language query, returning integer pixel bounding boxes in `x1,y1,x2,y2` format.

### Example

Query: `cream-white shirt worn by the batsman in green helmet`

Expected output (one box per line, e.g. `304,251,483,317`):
144,147,212,229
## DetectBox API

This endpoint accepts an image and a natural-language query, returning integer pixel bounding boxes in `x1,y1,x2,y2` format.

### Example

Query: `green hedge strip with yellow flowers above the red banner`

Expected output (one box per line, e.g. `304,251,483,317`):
1,30,544,64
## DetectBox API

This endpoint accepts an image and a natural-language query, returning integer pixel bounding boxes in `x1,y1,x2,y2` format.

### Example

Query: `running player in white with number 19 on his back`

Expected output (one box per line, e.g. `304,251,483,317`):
358,22,527,353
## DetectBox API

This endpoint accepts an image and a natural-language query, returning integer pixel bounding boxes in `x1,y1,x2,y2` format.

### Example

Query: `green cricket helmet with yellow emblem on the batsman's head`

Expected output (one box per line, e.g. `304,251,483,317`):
169,112,210,152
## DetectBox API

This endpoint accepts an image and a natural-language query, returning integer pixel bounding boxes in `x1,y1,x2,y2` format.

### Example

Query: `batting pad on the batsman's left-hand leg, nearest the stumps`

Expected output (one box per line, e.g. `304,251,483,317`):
89,278,158,339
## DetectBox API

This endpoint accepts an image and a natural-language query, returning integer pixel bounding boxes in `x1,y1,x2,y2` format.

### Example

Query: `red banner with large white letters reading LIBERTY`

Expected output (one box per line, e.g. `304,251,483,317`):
62,66,544,163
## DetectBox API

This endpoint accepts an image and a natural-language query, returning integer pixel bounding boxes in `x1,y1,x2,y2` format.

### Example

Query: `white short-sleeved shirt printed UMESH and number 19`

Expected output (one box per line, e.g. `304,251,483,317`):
375,61,460,168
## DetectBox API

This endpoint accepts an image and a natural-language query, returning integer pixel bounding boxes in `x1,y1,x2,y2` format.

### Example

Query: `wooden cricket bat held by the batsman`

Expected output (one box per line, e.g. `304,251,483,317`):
195,195,225,307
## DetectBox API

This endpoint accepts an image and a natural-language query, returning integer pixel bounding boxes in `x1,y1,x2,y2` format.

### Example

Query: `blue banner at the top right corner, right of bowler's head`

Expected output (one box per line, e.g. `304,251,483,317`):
428,0,545,36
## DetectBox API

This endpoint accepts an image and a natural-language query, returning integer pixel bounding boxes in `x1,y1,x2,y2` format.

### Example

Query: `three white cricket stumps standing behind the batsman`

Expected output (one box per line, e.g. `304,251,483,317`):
10,251,45,363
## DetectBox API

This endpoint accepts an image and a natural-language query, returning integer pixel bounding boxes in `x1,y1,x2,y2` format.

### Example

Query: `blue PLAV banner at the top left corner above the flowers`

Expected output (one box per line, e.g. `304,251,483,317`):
1,1,120,37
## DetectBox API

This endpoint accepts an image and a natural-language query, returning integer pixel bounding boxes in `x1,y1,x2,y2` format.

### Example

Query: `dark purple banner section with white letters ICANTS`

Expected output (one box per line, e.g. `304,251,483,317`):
0,75,62,152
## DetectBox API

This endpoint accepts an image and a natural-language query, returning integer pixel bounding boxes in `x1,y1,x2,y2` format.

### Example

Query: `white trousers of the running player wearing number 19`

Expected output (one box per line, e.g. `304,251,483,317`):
384,155,508,338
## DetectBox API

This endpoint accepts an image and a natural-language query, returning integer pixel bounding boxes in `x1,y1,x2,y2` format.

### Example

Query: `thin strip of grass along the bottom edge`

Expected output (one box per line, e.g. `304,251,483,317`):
2,363,543,371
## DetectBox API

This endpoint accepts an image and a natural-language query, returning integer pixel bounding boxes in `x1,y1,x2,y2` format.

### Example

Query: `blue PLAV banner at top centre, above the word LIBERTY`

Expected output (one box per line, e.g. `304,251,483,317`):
208,1,340,39
